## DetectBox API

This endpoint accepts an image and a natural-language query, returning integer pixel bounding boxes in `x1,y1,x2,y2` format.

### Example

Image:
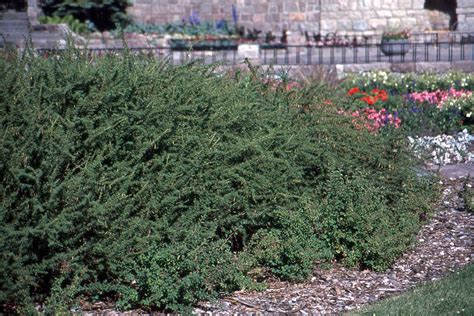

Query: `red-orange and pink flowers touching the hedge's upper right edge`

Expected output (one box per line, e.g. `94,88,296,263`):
342,87,401,132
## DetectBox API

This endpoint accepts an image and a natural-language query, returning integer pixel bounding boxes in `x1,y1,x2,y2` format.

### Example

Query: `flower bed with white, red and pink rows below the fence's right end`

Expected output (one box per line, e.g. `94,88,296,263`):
342,71,474,135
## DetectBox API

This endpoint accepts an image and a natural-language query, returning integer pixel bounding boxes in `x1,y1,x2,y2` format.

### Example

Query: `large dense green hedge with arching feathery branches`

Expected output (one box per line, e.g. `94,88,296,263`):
0,49,431,312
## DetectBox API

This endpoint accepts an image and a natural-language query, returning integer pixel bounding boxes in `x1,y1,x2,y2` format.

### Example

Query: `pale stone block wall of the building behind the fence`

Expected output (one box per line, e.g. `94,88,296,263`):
128,0,474,35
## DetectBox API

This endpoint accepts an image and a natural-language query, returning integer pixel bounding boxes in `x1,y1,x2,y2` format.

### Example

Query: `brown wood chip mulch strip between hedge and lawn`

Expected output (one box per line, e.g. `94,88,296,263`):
194,169,474,315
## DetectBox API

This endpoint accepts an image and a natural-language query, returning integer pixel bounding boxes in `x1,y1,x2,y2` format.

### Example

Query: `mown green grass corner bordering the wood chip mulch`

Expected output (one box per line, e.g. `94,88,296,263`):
350,264,474,315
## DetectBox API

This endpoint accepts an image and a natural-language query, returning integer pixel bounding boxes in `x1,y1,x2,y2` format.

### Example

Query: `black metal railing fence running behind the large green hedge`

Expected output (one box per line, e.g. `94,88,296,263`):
39,32,474,65
